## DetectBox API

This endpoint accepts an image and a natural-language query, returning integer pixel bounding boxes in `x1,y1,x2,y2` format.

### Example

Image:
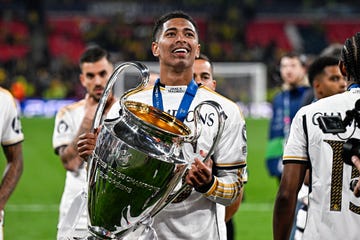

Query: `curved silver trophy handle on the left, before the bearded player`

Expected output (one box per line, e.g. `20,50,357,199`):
92,62,150,129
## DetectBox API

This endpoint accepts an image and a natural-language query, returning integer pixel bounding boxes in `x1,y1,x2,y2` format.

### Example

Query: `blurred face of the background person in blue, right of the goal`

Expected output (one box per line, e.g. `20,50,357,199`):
280,57,306,85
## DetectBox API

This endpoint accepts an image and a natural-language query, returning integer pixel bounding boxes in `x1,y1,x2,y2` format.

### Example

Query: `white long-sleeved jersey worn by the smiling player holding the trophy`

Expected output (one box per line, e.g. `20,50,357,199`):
108,86,247,240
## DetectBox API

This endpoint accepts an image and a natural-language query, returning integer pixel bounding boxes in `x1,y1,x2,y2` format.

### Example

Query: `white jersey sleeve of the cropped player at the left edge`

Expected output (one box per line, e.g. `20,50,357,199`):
0,87,24,146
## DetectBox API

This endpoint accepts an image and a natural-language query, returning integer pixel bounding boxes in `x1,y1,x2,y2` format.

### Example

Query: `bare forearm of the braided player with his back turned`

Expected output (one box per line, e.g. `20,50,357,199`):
273,163,306,240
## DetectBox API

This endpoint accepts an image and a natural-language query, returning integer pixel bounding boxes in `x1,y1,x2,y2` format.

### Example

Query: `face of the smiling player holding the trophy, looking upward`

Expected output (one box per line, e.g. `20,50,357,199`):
152,18,200,68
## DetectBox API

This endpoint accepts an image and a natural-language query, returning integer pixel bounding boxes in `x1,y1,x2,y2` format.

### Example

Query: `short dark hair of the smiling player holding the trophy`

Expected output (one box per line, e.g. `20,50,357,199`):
152,10,199,42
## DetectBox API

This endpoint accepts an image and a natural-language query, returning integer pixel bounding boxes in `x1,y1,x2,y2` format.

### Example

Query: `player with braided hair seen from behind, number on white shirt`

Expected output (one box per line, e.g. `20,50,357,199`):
273,33,360,240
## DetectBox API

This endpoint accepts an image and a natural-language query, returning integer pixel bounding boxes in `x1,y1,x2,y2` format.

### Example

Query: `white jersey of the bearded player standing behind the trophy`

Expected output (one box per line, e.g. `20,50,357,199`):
53,100,87,229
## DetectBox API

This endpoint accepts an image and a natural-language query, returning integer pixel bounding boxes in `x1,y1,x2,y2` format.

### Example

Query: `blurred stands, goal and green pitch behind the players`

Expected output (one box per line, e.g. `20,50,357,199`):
0,0,360,240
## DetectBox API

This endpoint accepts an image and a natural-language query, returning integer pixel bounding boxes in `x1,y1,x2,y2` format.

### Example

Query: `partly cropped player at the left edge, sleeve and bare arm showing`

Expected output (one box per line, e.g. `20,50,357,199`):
0,87,24,240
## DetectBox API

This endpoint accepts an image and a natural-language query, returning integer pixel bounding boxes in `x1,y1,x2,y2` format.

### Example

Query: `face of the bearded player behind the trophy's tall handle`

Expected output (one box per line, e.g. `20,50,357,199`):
80,57,113,101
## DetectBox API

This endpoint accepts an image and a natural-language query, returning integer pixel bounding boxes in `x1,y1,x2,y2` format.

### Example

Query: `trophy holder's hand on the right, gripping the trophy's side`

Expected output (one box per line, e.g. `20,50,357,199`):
186,151,213,192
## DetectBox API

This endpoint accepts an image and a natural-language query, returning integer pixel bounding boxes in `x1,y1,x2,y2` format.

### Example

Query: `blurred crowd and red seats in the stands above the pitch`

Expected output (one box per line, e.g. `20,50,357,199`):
0,0,360,115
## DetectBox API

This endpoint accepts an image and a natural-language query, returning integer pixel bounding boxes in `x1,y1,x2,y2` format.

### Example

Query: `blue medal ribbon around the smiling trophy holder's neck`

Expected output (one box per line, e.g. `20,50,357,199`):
153,78,199,122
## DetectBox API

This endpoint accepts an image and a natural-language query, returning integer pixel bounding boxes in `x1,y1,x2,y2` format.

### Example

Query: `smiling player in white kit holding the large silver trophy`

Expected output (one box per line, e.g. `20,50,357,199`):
78,11,247,240
